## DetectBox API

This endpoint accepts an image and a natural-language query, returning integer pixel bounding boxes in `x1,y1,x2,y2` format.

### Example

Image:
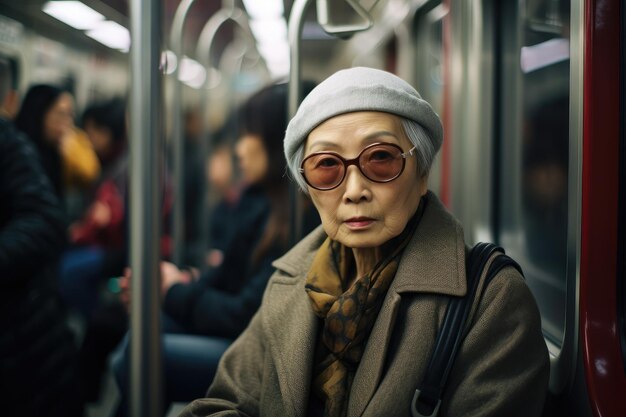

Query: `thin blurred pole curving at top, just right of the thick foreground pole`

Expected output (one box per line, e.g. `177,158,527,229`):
170,0,195,265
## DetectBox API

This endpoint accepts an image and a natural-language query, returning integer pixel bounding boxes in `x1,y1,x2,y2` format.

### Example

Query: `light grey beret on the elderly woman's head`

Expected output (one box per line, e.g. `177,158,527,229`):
285,67,443,160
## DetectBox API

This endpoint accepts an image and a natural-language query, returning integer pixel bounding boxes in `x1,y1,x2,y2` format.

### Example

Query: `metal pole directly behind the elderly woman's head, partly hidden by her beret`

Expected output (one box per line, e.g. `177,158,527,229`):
287,0,312,244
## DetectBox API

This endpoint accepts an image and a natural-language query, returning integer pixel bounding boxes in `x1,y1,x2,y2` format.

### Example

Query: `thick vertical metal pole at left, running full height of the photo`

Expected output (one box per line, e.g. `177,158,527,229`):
130,0,162,417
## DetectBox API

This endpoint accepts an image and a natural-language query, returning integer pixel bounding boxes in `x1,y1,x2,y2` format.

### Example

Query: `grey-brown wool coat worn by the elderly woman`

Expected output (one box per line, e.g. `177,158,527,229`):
181,193,549,417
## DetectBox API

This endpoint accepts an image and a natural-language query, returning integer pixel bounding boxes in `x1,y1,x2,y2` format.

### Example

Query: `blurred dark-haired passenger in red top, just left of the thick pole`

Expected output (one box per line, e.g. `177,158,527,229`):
61,99,128,318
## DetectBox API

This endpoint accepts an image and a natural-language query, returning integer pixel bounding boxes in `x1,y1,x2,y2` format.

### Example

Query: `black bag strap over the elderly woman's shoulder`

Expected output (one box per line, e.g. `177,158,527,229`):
411,242,522,417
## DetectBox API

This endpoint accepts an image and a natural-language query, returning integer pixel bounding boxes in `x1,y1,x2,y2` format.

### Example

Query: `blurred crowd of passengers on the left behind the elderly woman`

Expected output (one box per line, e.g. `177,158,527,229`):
0,59,312,416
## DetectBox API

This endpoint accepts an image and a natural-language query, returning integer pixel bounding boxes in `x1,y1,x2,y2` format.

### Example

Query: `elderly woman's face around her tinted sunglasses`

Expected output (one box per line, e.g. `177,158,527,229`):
304,112,428,248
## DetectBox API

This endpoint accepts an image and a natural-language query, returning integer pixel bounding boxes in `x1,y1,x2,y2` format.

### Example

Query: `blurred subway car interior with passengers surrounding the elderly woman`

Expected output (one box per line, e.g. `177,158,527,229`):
0,0,626,417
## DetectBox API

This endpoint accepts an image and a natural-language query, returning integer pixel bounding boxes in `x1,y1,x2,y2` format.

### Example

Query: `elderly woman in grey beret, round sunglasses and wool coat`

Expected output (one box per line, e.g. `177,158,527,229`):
182,68,549,417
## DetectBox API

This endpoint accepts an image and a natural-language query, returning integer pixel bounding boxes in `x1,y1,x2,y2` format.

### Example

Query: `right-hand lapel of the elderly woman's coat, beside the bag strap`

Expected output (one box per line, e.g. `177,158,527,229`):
348,193,467,416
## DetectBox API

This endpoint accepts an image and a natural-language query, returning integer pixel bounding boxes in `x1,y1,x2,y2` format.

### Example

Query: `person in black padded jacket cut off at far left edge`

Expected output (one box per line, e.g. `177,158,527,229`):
0,60,82,417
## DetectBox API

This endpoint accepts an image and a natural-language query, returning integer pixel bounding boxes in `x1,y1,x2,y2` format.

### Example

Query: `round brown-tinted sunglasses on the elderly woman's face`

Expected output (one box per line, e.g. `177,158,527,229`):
300,143,415,191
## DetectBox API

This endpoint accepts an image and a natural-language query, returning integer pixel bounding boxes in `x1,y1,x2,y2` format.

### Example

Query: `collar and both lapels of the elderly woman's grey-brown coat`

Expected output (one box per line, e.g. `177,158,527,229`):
264,192,466,417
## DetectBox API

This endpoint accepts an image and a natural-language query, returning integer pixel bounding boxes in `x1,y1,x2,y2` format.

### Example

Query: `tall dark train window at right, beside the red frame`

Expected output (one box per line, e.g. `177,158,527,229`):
497,0,570,347
